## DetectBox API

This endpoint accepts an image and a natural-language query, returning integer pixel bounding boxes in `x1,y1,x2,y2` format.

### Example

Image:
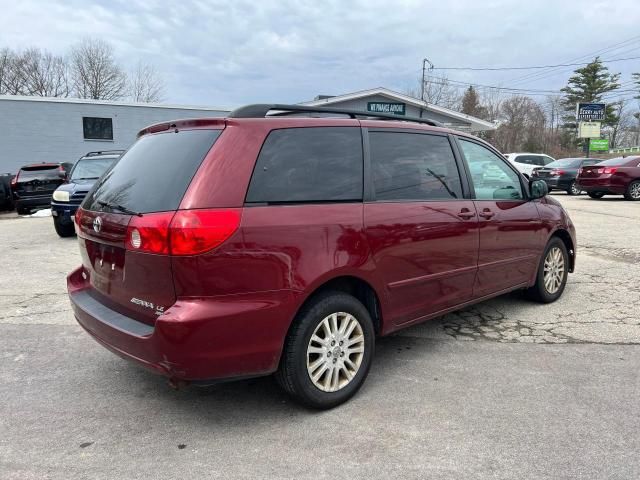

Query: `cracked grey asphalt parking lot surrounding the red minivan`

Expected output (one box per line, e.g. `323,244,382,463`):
0,193,640,479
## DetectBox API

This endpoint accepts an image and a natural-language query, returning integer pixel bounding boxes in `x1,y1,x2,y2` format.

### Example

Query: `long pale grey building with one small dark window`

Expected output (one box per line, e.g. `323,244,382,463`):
0,95,229,173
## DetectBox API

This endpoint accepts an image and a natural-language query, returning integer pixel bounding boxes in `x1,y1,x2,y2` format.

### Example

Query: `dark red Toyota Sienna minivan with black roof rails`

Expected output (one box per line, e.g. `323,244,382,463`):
68,105,576,408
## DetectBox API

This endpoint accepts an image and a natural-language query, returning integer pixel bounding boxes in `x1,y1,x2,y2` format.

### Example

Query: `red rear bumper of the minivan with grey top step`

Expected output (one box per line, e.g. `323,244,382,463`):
67,267,297,382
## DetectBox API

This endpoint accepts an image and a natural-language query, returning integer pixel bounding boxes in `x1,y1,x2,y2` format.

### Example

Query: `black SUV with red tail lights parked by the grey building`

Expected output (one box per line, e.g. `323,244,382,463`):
11,163,66,215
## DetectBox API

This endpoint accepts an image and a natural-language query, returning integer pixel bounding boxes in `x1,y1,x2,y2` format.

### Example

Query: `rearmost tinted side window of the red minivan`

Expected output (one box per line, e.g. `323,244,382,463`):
246,127,363,203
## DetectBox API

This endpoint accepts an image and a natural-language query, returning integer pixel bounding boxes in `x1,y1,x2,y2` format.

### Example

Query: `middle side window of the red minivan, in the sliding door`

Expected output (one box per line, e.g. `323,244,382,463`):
369,132,462,201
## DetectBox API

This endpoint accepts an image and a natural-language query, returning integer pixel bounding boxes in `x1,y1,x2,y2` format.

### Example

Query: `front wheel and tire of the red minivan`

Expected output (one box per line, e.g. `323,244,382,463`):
527,237,569,303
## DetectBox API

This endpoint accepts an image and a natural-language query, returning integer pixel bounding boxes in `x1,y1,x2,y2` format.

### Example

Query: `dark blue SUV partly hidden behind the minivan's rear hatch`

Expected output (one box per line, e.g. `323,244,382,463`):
51,150,124,237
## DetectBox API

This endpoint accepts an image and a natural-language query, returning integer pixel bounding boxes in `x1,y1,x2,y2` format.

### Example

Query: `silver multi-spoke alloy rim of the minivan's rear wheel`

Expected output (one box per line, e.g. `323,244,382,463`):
307,312,365,392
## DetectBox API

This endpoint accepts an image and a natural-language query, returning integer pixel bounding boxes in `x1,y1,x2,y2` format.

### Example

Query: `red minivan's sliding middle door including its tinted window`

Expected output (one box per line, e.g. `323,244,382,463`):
364,129,478,325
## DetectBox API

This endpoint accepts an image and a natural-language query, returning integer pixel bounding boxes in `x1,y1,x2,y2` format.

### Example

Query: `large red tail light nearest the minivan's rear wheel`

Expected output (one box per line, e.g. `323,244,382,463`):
126,209,240,255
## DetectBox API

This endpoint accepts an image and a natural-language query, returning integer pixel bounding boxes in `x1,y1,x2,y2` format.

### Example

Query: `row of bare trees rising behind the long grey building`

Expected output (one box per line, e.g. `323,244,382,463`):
0,38,164,103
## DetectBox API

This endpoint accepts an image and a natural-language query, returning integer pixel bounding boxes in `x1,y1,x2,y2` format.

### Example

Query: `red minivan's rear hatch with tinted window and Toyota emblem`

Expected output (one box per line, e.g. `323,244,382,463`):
76,129,221,324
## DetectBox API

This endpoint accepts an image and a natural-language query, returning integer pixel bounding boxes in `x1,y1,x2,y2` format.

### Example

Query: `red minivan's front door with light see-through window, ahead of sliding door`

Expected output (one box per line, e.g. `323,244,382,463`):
458,137,544,298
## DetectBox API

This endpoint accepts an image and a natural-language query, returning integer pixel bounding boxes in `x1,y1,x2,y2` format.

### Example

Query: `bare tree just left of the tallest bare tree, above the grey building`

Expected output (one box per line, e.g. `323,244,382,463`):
21,48,70,97
